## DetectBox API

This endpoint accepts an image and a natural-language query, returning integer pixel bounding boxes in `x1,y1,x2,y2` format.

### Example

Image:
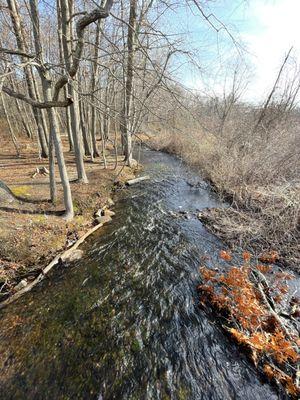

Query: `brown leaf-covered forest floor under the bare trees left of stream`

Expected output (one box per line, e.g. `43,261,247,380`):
0,132,134,297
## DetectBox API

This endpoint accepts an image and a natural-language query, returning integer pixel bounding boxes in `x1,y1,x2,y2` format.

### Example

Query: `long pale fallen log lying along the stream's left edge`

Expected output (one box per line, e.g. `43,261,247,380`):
0,223,103,310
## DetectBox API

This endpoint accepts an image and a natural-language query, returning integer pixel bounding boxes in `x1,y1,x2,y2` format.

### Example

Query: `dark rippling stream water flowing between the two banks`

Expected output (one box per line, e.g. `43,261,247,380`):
0,150,285,400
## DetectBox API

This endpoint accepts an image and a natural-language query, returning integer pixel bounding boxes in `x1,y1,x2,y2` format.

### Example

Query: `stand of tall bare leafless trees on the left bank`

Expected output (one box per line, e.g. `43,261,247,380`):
0,0,176,220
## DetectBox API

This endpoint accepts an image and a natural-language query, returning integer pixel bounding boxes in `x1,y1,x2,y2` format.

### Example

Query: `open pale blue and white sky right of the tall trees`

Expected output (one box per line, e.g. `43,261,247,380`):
170,0,300,102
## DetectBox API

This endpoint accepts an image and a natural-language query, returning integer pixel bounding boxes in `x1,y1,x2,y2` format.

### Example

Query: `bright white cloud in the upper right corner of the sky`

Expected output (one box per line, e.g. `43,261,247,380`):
242,0,300,100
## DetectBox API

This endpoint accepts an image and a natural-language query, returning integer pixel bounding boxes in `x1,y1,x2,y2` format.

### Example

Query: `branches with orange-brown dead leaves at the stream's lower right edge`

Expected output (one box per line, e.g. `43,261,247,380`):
198,251,300,398
